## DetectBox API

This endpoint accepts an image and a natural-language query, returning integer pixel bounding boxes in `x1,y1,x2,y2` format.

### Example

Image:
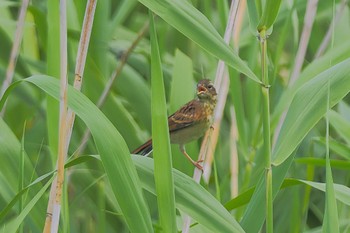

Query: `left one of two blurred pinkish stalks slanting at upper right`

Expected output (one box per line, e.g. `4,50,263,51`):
272,0,318,148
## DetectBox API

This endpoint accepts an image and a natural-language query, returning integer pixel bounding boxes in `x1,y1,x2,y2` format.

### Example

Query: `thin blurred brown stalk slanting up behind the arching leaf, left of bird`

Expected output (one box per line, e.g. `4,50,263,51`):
76,22,149,155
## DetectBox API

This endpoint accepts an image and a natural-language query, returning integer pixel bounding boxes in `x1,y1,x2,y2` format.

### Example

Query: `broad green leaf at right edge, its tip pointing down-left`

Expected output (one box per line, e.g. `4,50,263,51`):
273,59,350,165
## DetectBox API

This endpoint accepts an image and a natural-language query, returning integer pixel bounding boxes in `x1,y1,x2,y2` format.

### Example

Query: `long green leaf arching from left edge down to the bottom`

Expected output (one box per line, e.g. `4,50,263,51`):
0,75,153,232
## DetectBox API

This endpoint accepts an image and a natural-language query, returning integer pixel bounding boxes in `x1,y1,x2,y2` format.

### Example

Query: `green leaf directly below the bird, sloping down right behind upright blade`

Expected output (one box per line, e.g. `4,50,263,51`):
133,156,244,232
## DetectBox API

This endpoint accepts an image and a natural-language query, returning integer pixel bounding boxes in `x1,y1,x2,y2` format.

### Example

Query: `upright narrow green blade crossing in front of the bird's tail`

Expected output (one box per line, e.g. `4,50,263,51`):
149,12,177,232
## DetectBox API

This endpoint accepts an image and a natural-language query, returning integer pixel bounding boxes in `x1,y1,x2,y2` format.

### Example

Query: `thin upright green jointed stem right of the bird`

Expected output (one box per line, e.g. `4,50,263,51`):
260,29,273,233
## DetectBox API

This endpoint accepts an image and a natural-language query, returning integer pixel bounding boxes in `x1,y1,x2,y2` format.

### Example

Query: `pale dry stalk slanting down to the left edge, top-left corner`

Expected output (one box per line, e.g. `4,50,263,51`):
0,0,29,117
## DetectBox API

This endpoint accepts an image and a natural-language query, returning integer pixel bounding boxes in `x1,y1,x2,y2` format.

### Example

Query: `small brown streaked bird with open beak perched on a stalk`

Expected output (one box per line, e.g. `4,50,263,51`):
132,79,217,170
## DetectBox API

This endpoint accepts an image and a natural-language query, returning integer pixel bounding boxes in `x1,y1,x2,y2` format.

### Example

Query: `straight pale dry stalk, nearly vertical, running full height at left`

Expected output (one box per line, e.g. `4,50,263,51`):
44,0,68,233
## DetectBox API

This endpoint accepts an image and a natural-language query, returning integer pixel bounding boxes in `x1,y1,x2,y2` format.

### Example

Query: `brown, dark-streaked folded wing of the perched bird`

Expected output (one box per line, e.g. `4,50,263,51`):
168,100,201,132
